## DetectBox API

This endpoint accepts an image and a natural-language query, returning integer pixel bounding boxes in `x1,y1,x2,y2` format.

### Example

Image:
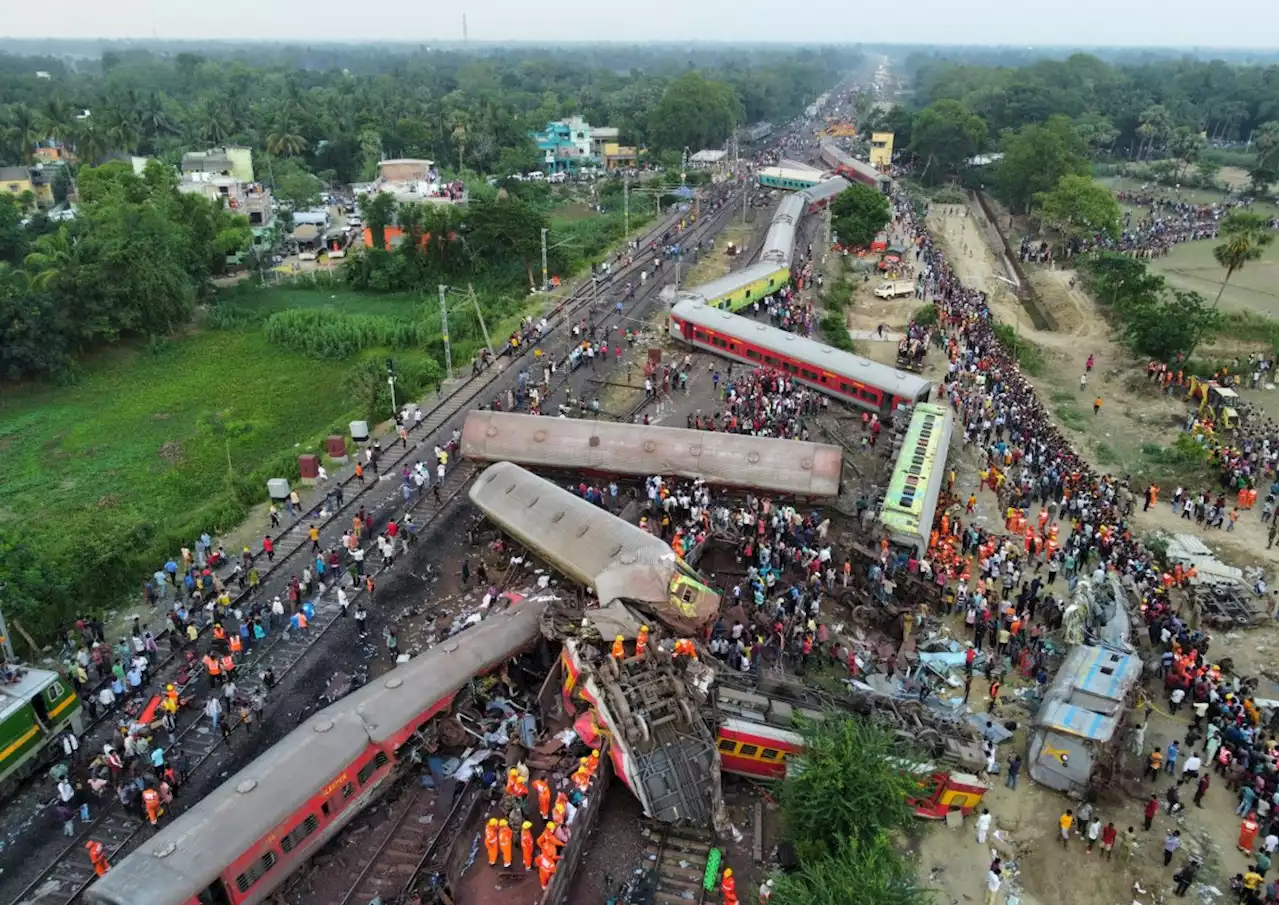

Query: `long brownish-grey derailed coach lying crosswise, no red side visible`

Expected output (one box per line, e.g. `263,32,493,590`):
462,411,841,497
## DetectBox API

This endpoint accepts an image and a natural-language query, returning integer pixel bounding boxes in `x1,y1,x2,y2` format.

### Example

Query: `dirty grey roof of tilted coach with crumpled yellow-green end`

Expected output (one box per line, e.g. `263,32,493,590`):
470,462,719,623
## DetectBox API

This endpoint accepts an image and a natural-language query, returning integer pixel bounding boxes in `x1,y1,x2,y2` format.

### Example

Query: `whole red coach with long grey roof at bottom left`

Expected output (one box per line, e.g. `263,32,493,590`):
86,602,544,905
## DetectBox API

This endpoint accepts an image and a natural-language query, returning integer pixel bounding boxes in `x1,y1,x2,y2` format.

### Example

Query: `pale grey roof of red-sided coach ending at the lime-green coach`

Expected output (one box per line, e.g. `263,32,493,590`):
671,300,931,399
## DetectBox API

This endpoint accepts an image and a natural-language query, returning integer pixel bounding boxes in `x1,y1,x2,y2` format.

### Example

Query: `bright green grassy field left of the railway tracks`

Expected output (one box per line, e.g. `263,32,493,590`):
0,288,458,636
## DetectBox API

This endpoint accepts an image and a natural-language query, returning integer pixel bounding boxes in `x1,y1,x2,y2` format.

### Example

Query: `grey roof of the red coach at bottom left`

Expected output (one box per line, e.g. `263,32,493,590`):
88,603,543,905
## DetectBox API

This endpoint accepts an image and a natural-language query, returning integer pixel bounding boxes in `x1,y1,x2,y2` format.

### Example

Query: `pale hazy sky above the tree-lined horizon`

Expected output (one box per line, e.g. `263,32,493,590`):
0,0,1280,49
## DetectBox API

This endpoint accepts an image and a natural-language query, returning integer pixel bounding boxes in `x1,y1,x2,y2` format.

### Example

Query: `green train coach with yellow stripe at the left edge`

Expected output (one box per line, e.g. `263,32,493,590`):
0,666,84,794
